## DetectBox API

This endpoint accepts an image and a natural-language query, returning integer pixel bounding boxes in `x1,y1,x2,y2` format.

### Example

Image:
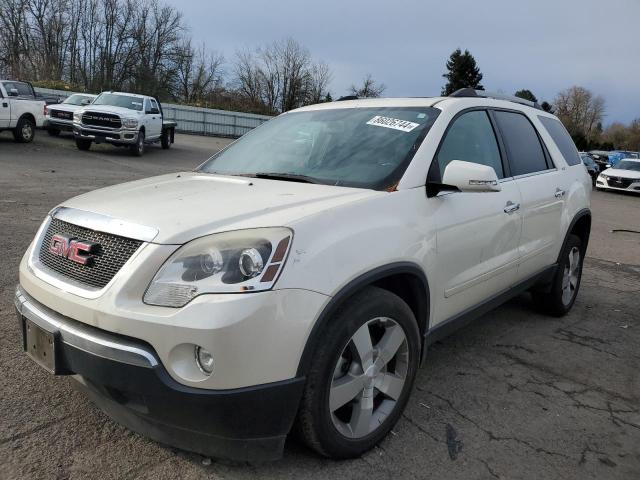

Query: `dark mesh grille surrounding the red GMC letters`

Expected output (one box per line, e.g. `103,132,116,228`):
39,218,142,288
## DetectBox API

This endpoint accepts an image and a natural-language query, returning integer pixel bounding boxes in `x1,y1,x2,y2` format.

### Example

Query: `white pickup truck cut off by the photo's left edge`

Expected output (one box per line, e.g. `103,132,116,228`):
0,80,45,143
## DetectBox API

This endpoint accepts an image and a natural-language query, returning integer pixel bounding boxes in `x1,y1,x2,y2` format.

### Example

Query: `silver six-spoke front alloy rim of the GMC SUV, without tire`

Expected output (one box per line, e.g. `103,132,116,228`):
329,317,409,439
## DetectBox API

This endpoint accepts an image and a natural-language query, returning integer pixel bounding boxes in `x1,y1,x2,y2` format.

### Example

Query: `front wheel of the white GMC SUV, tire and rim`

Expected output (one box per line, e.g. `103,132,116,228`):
297,287,420,458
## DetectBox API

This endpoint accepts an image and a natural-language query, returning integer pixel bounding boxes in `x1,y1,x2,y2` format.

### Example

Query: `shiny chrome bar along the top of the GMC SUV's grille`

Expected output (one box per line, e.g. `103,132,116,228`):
51,207,158,242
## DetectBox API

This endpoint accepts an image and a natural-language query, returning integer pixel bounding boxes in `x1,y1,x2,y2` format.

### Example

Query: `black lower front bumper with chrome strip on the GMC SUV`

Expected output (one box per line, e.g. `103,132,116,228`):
14,287,304,461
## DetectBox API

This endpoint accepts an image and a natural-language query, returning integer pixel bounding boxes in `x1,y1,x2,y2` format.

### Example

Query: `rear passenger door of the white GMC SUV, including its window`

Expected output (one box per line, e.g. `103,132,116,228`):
492,110,569,280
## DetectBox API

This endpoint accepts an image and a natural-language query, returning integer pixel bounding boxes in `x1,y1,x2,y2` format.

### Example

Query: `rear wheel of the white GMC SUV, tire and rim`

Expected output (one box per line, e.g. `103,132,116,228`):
533,235,583,317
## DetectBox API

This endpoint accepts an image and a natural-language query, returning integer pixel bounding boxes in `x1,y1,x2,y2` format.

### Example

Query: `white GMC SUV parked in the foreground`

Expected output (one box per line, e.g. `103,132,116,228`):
15,90,591,460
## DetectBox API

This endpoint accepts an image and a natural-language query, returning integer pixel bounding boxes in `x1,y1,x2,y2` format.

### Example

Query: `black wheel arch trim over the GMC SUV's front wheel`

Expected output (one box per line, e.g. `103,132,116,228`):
297,262,430,377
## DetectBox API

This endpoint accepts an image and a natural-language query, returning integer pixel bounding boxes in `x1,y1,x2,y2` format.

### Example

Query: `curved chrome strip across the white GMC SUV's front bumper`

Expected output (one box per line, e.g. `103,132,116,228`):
14,285,159,368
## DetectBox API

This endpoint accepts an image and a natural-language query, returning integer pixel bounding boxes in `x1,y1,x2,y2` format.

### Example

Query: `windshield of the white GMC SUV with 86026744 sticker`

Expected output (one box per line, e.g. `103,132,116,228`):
200,107,439,190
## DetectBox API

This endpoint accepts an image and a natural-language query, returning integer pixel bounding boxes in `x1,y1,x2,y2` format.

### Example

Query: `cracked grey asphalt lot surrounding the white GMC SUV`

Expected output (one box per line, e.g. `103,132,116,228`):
0,132,640,480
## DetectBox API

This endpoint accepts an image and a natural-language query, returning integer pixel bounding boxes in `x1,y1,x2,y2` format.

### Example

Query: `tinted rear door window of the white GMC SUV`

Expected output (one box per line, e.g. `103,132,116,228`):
495,111,547,177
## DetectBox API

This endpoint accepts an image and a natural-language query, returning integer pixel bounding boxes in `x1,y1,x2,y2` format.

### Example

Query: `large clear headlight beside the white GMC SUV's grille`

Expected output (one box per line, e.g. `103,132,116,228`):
144,227,293,307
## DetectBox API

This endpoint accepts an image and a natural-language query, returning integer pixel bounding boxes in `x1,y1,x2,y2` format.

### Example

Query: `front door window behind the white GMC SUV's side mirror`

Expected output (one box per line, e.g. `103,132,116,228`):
437,110,504,178
